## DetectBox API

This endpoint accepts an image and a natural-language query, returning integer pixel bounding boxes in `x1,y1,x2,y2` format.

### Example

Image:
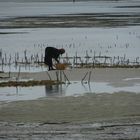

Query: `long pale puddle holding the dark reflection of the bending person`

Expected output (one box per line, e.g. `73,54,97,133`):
0,82,140,102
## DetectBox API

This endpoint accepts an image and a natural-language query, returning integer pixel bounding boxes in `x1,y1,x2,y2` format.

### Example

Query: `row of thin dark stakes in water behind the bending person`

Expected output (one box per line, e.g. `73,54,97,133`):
0,50,140,71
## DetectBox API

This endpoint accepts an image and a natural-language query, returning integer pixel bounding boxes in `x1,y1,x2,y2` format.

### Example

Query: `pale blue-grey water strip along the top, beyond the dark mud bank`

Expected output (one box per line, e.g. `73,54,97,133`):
0,0,140,19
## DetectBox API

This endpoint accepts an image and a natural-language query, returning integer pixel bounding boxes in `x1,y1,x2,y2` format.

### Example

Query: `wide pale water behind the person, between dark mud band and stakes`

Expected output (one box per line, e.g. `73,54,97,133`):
0,26,140,71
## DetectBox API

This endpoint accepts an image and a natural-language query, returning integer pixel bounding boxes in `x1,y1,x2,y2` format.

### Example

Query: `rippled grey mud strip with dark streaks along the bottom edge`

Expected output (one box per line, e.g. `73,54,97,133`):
0,119,140,140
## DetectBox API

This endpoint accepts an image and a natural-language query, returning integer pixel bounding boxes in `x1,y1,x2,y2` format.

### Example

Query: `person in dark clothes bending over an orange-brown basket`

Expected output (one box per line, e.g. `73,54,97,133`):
44,47,65,70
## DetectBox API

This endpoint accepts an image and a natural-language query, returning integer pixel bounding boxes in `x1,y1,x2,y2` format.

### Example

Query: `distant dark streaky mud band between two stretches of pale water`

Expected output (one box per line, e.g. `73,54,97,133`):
0,13,140,28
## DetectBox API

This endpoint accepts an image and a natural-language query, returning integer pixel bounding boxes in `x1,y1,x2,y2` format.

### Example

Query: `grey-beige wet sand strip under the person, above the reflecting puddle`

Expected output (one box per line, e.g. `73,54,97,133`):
1,68,140,86
